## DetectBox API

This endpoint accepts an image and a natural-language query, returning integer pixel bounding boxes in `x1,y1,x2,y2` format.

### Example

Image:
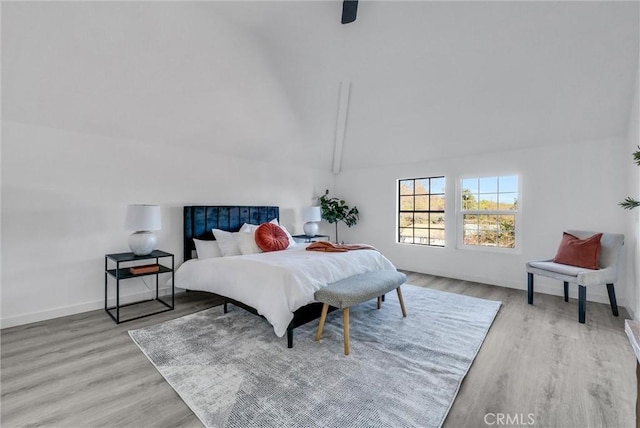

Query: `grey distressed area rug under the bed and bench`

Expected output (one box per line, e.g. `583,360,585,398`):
129,285,501,428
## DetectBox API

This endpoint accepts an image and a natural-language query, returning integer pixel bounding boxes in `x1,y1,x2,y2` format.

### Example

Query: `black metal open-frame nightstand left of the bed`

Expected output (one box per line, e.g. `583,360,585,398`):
104,250,175,324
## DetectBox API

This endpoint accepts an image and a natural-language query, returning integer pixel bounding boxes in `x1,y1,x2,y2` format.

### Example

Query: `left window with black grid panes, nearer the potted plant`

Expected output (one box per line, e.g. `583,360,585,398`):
398,177,444,247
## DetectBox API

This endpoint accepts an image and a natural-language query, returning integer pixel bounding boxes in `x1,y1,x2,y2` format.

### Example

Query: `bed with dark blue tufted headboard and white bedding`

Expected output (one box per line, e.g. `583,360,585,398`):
176,206,395,348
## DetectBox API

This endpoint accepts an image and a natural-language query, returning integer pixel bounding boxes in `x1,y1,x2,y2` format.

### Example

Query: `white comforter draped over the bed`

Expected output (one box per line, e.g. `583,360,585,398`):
175,244,395,337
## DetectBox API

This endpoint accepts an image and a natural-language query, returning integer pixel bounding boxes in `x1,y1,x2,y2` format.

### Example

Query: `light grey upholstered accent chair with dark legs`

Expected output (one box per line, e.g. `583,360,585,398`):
527,230,624,324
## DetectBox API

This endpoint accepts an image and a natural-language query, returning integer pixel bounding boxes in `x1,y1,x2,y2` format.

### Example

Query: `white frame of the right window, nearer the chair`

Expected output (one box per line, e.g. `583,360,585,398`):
455,172,523,254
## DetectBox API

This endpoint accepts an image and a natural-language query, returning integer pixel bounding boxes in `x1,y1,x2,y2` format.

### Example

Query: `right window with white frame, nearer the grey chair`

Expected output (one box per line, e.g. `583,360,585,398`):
460,175,518,248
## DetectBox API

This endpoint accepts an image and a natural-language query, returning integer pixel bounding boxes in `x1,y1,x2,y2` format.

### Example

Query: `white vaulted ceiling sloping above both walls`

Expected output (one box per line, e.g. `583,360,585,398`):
2,0,640,170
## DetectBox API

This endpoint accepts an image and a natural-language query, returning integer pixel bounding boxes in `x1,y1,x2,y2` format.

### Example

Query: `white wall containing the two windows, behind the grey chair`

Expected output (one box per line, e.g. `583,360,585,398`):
336,135,628,306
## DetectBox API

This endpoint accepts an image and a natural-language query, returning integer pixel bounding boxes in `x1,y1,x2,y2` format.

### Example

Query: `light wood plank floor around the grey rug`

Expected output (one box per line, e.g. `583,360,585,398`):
0,273,636,428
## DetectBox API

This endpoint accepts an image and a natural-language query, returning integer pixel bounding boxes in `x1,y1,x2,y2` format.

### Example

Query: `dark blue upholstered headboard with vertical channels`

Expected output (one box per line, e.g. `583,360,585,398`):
183,205,280,262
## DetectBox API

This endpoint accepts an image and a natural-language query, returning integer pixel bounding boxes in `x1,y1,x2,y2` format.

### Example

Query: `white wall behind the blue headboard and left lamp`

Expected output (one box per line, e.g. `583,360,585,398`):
1,121,334,327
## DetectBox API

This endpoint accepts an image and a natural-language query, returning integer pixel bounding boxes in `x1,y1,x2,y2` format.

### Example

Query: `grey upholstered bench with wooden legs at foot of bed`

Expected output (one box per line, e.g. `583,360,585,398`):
315,270,407,355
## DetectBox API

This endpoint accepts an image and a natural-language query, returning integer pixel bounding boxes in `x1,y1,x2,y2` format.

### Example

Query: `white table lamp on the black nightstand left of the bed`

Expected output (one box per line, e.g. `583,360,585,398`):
124,205,162,256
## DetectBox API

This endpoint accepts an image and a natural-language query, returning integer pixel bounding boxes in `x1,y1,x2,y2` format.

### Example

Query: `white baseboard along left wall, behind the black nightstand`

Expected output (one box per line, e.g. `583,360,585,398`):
0,287,178,329
